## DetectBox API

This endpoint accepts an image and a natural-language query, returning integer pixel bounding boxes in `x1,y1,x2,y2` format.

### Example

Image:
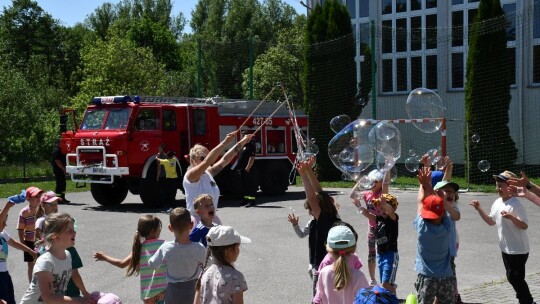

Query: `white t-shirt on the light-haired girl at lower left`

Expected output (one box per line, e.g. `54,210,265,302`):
19,250,71,304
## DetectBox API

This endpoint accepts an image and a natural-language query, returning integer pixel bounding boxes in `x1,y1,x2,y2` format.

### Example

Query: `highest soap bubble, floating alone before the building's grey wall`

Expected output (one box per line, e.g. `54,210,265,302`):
405,88,445,133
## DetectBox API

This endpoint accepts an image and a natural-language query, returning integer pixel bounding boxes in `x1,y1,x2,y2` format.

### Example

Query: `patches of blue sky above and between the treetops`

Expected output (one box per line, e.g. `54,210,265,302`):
0,0,306,32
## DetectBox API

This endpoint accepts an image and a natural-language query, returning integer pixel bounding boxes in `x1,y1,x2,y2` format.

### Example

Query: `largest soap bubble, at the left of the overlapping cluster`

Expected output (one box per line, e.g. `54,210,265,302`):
328,120,375,179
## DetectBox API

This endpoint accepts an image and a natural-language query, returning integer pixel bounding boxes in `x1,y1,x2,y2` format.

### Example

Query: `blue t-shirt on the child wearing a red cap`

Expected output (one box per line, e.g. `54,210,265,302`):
413,215,455,278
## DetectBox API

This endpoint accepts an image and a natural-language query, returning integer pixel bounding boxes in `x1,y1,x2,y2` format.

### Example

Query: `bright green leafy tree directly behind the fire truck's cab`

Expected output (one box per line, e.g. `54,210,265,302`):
73,36,165,110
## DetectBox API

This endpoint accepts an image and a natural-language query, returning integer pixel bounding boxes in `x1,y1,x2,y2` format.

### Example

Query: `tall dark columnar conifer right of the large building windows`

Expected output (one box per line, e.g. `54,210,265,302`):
465,0,517,183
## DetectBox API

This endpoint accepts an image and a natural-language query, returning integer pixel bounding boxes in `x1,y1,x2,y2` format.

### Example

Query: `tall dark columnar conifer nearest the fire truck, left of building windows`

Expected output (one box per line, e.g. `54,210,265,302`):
304,0,357,180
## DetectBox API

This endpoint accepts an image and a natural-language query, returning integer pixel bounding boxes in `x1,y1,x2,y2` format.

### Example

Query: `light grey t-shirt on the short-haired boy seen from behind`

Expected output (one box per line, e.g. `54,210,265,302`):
148,241,206,283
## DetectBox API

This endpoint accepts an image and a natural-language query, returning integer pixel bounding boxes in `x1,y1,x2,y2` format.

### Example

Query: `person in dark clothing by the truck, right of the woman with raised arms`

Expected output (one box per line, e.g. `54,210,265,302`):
235,139,257,207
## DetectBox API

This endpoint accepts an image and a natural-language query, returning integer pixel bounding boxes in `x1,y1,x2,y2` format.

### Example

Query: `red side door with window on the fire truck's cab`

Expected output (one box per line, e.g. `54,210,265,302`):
128,107,162,175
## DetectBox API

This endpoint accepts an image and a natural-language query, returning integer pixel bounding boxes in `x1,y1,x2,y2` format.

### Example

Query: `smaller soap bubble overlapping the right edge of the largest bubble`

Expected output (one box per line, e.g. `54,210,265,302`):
368,121,401,161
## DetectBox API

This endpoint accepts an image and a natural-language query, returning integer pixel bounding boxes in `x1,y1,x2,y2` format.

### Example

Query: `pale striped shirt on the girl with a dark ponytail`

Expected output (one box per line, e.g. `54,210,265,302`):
139,239,167,300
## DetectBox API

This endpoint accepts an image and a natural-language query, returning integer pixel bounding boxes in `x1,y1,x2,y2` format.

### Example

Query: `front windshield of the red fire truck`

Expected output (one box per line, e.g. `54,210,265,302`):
81,108,131,130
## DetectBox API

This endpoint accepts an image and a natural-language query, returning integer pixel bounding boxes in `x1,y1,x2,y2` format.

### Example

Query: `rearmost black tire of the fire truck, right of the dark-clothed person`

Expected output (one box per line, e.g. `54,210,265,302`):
260,160,290,195
